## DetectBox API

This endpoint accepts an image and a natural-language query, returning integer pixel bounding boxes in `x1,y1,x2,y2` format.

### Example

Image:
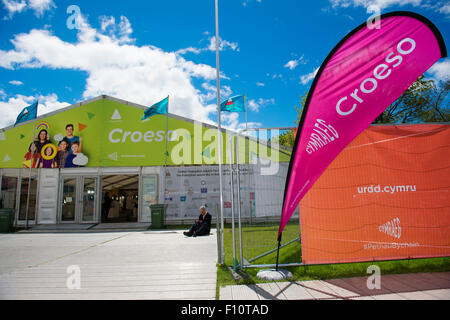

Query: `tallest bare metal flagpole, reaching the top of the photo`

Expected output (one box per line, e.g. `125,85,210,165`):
215,0,225,264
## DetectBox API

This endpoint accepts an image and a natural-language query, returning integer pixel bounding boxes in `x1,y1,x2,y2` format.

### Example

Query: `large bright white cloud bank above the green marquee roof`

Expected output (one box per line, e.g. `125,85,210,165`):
0,13,231,124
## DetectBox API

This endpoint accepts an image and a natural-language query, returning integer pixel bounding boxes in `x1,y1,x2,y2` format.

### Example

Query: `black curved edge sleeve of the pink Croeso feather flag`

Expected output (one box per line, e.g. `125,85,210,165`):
278,11,447,242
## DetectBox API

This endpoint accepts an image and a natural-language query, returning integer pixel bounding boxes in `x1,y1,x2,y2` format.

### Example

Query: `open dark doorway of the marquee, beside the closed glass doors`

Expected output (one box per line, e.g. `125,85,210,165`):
101,174,139,223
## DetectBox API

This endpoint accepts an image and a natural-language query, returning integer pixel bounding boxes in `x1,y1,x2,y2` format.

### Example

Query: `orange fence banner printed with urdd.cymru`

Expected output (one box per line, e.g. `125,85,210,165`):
300,124,450,264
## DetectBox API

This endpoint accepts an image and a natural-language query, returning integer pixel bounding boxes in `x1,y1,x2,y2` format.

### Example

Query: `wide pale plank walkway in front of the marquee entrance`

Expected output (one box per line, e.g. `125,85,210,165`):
0,230,217,300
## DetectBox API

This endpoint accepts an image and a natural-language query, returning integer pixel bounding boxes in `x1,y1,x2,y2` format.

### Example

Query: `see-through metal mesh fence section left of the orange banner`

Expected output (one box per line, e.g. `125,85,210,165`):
224,136,301,270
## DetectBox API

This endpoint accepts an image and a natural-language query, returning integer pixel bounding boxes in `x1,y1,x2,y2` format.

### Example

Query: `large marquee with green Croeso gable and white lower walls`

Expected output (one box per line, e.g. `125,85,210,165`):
0,96,291,226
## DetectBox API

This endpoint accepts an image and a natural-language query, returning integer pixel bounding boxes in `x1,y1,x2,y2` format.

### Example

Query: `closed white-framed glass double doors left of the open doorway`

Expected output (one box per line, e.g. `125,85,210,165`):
60,176,98,223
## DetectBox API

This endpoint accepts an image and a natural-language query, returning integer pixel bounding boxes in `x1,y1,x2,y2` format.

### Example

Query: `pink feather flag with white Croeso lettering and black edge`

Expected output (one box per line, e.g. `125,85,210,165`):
278,11,447,240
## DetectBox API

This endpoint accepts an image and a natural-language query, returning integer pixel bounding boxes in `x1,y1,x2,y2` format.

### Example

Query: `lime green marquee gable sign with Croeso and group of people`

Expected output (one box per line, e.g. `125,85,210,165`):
0,99,290,168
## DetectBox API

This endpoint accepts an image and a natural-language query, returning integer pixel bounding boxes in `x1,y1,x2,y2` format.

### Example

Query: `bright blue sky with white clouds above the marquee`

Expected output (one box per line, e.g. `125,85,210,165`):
0,0,450,129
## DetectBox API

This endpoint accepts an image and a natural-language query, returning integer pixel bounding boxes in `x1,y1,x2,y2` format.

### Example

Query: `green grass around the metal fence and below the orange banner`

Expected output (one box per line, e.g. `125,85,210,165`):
216,223,450,299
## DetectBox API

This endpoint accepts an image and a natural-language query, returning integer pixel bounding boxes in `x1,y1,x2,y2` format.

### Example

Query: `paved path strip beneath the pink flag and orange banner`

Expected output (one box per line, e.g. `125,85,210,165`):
220,272,450,300
